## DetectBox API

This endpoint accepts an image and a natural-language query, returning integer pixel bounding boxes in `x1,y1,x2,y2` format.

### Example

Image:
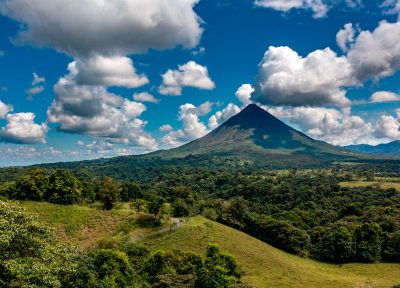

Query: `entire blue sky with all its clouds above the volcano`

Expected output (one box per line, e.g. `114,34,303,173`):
0,0,400,166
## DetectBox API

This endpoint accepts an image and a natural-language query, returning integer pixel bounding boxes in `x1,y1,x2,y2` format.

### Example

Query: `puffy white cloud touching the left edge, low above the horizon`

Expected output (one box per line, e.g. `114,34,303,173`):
0,113,48,144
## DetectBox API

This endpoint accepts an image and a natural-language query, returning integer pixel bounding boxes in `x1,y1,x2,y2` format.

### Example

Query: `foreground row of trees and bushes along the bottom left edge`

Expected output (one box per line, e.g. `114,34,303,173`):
0,201,250,288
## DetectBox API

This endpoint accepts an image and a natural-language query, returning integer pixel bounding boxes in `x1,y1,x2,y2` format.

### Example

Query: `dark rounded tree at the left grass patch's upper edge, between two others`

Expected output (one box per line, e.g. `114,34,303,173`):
45,170,82,205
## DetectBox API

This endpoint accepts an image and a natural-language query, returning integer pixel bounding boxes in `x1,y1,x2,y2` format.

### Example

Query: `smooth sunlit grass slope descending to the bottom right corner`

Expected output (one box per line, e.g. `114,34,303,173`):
144,217,400,288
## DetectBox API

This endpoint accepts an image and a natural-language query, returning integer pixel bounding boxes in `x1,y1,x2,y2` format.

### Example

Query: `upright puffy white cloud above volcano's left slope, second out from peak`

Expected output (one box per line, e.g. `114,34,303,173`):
161,103,208,146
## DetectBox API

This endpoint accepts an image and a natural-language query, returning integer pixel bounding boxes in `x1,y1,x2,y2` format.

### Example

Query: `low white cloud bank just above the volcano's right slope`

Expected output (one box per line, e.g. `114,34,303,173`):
267,107,376,145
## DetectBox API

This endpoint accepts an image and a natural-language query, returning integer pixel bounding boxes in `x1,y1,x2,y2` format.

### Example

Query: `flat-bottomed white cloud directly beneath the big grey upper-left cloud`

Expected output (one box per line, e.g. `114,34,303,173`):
70,55,149,88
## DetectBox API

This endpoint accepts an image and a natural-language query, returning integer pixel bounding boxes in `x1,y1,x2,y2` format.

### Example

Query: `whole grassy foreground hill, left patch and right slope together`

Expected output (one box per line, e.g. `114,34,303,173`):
15,202,400,288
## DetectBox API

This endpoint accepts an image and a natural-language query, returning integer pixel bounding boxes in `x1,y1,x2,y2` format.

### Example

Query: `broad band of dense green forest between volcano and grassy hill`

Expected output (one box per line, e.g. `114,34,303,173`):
0,166,400,263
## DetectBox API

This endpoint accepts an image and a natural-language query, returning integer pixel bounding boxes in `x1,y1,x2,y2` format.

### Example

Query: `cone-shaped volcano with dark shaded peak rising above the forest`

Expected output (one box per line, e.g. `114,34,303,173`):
150,104,360,166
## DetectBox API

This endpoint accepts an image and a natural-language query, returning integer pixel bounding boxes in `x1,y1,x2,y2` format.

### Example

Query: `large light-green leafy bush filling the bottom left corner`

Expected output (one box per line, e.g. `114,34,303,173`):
0,201,77,288
